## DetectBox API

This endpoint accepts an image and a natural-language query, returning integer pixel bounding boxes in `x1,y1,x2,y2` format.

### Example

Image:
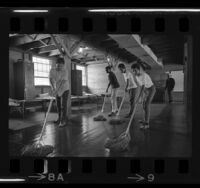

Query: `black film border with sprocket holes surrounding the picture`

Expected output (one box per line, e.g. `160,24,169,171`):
1,9,200,183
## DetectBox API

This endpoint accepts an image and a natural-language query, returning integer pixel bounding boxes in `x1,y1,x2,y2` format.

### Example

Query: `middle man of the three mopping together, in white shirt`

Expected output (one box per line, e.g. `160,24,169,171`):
118,63,141,118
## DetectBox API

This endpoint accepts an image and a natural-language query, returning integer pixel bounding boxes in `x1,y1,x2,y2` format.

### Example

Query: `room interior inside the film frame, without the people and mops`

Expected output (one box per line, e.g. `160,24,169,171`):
8,34,192,157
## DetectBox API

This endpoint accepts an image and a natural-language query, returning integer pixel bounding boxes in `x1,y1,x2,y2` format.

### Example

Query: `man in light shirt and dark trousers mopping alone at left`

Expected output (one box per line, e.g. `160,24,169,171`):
49,58,70,127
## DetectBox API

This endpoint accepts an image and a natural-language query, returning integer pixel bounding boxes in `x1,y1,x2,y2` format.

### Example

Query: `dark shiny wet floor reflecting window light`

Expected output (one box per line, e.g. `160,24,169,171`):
9,104,192,157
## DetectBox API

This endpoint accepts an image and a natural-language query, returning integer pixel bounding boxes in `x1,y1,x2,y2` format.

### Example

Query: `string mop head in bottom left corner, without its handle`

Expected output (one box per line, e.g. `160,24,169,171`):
22,144,54,157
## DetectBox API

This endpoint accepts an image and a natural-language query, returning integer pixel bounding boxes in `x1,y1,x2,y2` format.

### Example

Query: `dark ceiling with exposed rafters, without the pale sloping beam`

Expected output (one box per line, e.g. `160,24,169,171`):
9,34,183,65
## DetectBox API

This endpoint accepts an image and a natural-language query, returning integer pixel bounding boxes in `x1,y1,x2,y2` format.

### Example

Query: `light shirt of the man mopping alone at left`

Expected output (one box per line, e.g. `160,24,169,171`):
49,68,70,96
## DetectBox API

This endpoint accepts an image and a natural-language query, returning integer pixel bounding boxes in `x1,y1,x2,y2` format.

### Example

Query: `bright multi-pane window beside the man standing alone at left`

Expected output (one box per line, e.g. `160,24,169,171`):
32,56,51,86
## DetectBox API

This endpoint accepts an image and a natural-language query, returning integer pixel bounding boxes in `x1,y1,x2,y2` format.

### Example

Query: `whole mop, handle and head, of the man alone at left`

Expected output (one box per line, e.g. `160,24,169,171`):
22,98,54,157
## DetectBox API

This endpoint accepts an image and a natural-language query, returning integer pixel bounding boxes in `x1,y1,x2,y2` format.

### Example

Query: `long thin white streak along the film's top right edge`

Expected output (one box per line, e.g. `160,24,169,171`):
88,8,200,12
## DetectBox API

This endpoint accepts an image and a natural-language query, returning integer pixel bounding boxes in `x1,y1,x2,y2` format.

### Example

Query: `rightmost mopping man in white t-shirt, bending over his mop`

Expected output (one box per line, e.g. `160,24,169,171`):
131,63,156,129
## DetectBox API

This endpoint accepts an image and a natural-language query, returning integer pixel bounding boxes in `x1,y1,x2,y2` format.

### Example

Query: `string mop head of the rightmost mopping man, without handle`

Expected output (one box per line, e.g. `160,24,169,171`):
104,133,131,152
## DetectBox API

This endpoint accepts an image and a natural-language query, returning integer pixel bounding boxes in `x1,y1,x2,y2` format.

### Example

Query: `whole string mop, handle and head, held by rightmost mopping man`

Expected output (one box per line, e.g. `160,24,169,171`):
104,89,142,152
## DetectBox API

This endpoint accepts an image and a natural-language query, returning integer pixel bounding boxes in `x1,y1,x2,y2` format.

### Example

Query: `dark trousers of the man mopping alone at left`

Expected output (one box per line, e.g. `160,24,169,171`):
56,90,69,121
